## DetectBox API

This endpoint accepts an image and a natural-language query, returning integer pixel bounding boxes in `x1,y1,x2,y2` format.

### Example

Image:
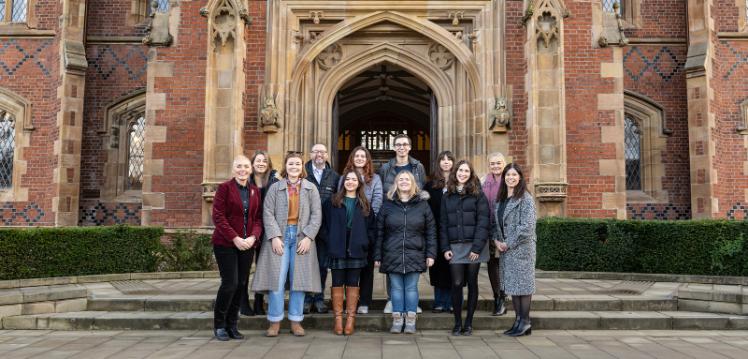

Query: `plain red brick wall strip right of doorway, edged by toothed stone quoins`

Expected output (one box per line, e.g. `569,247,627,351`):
563,1,616,217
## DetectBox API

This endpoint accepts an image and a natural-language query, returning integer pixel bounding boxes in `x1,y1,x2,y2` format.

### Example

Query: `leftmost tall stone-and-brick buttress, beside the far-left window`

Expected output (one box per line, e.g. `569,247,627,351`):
52,0,88,226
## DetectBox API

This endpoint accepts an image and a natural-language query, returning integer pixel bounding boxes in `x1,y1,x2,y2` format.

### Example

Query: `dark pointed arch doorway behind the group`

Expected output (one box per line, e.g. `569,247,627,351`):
332,62,439,171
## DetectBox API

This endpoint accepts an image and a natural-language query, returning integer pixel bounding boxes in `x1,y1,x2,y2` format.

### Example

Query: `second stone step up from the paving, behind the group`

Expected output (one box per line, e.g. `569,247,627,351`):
87,295,678,312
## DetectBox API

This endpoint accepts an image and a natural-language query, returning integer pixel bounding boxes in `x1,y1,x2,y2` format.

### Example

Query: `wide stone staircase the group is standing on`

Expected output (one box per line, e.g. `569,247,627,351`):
0,271,748,331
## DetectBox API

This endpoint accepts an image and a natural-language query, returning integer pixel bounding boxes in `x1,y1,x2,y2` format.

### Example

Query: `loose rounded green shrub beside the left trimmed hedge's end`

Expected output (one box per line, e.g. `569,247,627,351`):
159,232,214,272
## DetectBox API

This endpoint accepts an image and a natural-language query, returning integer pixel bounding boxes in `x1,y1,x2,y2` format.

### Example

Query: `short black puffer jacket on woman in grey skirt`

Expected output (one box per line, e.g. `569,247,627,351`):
439,192,491,253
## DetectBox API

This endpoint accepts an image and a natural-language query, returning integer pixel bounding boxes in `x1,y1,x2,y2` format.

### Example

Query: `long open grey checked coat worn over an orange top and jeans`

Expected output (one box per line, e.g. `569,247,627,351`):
252,179,322,293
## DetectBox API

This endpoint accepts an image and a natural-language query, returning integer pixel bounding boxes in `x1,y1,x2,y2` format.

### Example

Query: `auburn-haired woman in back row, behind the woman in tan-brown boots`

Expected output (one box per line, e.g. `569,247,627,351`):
340,146,384,314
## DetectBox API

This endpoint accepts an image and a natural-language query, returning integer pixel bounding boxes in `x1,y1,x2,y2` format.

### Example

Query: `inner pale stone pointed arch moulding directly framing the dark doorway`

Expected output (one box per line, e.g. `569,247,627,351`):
310,43,457,155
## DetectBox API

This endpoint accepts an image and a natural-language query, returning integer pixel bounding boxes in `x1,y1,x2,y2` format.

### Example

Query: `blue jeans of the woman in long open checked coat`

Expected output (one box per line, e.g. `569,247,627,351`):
268,226,304,322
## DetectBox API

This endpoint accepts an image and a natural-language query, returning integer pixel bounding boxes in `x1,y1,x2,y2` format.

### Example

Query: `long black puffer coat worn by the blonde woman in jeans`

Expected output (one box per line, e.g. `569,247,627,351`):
374,191,436,274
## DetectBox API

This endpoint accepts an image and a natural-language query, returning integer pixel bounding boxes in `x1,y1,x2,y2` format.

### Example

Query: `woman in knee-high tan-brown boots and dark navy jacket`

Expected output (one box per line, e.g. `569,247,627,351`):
322,170,374,335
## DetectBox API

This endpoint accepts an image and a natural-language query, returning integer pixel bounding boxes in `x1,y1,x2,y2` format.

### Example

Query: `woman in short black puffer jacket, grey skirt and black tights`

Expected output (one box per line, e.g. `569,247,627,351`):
439,160,490,335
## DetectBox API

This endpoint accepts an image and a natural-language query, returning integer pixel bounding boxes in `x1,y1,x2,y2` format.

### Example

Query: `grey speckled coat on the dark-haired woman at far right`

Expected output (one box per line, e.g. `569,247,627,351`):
493,192,537,295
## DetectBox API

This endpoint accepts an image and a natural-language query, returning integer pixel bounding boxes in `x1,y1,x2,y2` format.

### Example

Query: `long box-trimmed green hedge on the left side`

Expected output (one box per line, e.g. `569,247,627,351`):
0,226,164,280
